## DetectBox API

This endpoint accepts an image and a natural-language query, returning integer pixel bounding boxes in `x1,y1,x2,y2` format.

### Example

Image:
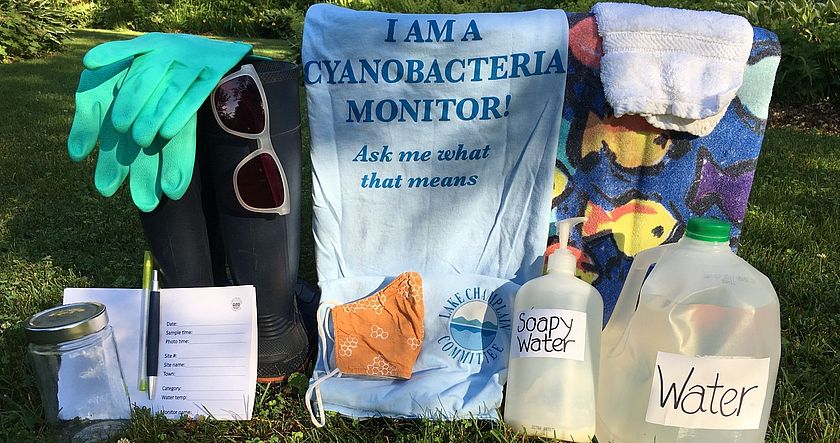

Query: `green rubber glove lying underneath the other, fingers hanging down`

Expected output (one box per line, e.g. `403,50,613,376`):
67,59,195,212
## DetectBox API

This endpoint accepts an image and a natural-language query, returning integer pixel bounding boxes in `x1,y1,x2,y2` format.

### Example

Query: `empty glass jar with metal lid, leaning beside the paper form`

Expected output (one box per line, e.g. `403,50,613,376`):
24,302,131,423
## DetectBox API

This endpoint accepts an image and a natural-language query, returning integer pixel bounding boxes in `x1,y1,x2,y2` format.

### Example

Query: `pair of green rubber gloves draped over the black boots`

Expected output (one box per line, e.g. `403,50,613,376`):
67,33,251,212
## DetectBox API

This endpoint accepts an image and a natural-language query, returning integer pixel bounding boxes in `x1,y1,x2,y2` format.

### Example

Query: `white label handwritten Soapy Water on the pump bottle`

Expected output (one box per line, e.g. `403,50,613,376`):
511,309,586,361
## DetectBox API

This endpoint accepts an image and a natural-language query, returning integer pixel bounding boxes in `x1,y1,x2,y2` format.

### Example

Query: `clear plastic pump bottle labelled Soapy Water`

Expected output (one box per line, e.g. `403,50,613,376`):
504,217,604,442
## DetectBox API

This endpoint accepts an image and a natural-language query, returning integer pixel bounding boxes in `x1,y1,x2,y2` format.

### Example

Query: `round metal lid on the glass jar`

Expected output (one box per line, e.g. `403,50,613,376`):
23,302,108,345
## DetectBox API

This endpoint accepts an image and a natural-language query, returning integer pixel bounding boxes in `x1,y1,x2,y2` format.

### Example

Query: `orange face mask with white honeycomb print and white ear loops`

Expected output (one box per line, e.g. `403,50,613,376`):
306,272,424,427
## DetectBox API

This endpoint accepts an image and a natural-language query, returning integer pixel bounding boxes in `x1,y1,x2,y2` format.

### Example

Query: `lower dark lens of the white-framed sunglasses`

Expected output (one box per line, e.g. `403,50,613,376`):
236,153,286,209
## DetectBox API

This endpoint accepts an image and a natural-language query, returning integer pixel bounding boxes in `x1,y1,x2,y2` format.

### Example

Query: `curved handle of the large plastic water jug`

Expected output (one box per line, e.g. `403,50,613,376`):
601,243,676,355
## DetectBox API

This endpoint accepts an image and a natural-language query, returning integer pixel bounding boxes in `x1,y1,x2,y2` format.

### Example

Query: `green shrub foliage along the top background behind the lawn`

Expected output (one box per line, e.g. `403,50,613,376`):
6,0,840,103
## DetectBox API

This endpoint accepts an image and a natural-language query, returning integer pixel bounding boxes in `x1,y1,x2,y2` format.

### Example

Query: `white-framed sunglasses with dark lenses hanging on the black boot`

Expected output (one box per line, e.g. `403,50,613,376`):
210,64,291,215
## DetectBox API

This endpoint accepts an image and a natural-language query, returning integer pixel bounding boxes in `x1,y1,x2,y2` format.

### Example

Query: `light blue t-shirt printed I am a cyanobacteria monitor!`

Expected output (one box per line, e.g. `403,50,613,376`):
302,5,568,418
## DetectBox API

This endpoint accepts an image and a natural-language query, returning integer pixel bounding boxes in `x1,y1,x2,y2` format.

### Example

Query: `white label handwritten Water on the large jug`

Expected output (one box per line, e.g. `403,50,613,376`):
645,352,770,429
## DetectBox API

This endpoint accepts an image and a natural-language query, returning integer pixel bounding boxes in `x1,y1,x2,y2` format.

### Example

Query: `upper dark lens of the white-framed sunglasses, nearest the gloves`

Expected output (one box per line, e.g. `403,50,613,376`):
214,75,265,134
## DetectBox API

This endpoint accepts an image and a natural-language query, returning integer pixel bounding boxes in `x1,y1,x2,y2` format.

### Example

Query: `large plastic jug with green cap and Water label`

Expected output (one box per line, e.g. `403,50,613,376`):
596,218,781,443
